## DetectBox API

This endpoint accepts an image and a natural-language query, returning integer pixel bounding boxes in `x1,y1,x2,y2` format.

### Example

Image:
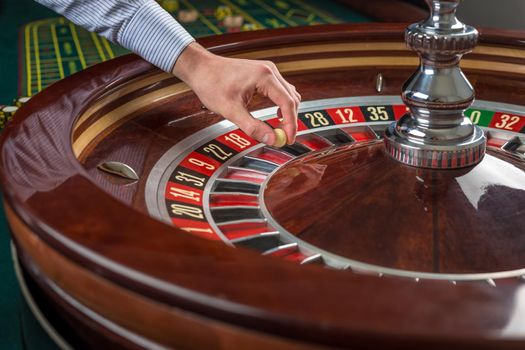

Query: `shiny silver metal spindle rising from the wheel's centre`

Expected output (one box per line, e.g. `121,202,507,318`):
385,0,486,169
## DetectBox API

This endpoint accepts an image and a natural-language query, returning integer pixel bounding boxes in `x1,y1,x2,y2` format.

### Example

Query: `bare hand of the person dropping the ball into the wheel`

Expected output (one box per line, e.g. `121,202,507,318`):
173,43,301,145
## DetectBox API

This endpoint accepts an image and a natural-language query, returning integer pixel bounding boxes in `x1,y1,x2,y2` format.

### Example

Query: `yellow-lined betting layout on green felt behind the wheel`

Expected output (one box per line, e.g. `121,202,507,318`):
19,0,368,96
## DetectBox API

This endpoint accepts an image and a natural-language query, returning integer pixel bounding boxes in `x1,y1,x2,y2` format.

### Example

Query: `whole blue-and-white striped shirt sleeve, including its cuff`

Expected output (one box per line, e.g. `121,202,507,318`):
36,0,194,72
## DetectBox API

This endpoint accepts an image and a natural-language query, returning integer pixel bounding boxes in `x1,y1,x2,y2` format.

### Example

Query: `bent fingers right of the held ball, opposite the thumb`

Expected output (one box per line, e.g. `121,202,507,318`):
259,70,300,144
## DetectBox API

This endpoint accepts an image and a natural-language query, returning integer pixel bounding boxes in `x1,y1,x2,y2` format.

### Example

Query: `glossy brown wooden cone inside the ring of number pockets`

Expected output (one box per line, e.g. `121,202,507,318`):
264,141,525,274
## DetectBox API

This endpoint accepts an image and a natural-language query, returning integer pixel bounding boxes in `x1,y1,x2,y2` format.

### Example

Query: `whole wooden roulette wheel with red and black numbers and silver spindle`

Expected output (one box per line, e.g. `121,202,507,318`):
0,0,525,349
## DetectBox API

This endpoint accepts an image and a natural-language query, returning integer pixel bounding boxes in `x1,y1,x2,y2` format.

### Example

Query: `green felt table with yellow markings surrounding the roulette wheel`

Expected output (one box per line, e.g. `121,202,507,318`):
0,0,369,349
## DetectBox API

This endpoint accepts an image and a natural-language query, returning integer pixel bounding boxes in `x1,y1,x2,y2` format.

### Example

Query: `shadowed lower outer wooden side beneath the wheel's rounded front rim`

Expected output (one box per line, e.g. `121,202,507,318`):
6,206,321,349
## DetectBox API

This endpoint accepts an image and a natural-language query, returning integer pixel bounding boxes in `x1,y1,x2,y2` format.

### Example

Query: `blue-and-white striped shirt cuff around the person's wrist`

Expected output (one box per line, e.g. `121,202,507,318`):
117,1,195,73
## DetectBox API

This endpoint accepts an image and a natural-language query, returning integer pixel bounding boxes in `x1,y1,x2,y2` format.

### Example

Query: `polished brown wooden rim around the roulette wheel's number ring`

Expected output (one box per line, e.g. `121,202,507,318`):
0,25,525,349
